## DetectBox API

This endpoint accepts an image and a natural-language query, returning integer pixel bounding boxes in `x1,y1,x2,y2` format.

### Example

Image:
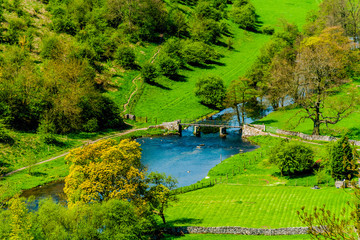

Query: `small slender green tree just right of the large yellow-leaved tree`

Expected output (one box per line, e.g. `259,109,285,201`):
148,172,177,224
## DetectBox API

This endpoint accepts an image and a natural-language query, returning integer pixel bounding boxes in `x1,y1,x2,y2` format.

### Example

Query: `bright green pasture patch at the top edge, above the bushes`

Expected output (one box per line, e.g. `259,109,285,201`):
251,0,321,30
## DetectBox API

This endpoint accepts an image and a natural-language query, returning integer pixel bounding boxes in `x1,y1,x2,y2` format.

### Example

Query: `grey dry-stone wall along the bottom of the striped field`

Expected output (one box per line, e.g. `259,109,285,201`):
167,227,308,235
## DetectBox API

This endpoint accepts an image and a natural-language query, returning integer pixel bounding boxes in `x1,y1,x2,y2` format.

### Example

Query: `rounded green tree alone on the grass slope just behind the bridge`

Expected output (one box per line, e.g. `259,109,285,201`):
195,75,226,109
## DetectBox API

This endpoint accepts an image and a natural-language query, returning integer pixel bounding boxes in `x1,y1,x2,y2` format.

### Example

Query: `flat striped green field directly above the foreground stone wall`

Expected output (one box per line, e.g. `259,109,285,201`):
166,184,351,228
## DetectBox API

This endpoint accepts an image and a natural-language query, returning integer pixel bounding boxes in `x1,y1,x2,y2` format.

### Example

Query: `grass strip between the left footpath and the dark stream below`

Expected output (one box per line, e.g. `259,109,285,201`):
0,157,69,201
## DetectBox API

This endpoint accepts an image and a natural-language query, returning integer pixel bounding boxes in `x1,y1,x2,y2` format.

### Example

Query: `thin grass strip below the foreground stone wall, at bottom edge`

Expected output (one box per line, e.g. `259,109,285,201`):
164,234,311,240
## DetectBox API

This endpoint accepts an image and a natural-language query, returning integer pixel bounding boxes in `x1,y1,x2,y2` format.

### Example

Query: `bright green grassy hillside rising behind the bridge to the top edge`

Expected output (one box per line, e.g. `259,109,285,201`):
134,0,318,121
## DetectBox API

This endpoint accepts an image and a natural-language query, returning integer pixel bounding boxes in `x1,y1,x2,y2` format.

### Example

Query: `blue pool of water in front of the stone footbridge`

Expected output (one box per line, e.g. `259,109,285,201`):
137,129,257,187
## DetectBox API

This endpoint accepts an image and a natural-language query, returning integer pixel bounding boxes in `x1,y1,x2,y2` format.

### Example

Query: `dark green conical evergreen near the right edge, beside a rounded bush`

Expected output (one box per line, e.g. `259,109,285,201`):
329,136,358,180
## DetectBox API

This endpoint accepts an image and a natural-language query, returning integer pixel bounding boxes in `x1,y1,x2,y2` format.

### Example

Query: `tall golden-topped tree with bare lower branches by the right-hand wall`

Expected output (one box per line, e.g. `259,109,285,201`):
296,27,357,135
